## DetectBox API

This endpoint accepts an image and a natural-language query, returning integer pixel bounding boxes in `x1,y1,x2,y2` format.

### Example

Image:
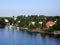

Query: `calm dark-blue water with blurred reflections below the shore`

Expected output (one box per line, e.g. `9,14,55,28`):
0,29,60,45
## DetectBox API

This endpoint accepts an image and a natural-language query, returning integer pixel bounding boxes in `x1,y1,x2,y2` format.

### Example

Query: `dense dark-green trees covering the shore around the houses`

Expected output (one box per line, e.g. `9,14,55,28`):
0,15,60,30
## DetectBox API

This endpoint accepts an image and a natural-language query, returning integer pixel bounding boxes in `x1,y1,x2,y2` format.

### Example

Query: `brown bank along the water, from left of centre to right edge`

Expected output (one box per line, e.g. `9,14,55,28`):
20,28,60,35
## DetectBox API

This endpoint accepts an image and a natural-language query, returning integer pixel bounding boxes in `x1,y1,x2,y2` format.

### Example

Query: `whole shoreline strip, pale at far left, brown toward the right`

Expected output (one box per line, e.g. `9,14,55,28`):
0,26,60,35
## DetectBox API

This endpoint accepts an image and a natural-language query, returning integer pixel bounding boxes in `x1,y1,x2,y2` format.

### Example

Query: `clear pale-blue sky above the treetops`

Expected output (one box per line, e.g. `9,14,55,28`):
0,0,60,17
